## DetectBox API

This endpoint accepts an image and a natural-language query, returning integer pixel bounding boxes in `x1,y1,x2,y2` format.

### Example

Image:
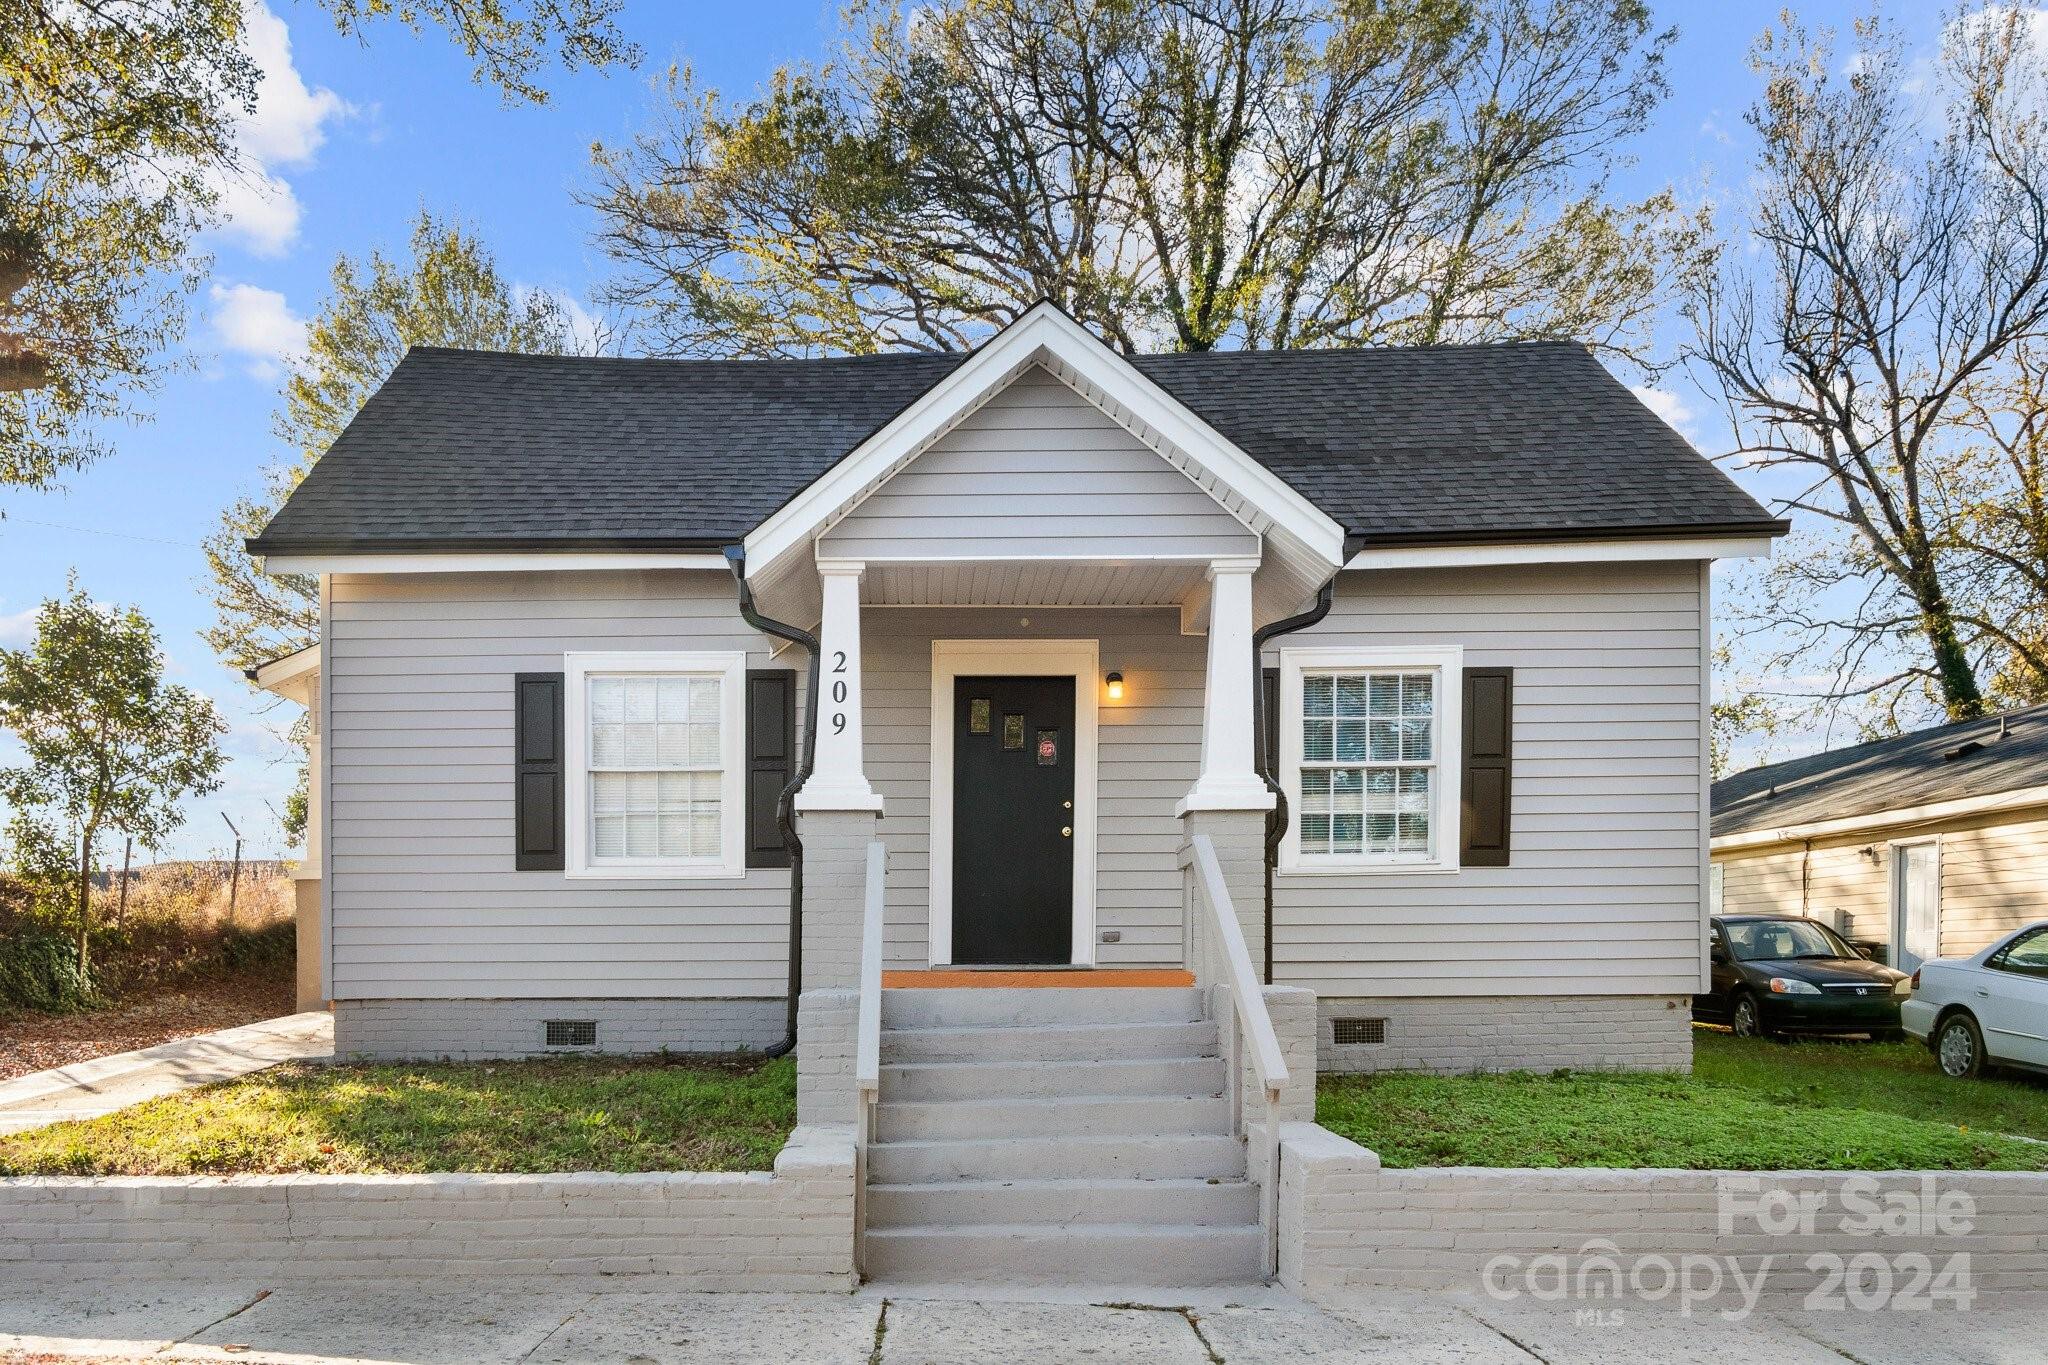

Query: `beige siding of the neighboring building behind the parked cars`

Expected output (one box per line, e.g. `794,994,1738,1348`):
1716,810,2048,958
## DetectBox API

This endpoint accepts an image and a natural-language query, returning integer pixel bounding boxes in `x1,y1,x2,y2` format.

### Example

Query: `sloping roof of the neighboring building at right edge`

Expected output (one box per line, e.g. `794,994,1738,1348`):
1712,706,2048,839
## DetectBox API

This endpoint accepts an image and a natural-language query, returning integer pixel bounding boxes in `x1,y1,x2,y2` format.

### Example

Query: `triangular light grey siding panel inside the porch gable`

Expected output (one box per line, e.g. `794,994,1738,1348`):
821,366,1260,559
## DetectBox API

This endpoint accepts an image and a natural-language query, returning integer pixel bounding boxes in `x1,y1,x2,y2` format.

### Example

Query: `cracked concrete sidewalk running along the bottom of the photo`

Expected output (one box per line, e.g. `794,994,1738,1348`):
0,1275,2042,1365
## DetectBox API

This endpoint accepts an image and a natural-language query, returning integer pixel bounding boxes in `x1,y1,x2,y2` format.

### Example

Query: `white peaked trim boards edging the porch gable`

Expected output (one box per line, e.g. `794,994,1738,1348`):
745,303,1343,569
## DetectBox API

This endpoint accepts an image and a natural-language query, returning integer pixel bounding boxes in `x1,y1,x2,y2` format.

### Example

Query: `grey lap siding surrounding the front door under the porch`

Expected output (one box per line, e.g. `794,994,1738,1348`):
860,608,1208,968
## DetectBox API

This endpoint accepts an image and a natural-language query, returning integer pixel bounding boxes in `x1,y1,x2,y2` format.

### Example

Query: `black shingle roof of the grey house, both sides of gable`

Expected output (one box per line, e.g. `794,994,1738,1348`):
250,342,1782,555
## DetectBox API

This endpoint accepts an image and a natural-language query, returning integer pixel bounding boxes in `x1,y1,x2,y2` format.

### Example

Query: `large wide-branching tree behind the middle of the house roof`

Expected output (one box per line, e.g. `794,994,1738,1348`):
584,0,1688,356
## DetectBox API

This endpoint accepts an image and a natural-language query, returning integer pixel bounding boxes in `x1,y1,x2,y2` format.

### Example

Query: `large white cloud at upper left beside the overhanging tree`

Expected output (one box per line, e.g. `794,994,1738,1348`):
213,0,354,256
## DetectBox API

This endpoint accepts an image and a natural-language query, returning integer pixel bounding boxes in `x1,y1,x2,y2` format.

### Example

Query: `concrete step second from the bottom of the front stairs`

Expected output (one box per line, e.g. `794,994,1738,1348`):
868,1179,1260,1228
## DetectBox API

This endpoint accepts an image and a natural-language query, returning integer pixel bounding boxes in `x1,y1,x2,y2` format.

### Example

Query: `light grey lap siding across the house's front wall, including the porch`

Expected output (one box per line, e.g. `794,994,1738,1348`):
326,565,1728,999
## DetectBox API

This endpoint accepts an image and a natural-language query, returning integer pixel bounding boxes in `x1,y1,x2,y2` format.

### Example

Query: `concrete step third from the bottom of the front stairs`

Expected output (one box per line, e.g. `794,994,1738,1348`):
868,1134,1245,1185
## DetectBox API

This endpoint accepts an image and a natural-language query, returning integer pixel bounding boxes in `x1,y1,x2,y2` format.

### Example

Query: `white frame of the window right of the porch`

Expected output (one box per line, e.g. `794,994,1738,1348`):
1280,645,1464,876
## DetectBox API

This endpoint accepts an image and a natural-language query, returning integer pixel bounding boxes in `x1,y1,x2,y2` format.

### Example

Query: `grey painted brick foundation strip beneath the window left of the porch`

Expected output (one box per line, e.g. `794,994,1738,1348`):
334,997,784,1062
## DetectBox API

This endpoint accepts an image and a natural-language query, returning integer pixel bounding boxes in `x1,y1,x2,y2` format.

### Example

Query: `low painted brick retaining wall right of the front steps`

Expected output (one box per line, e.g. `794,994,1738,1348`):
1280,1124,2048,1308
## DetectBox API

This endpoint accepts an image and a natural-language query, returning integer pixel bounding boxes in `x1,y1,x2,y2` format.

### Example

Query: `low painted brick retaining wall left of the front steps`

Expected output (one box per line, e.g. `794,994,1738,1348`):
0,1128,854,1291
